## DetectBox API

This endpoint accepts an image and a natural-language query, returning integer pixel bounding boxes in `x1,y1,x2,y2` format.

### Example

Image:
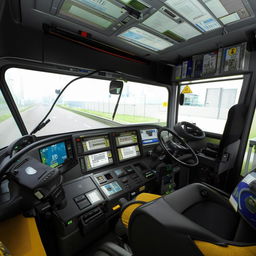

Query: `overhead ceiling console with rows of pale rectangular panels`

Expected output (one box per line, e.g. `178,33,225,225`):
22,0,255,55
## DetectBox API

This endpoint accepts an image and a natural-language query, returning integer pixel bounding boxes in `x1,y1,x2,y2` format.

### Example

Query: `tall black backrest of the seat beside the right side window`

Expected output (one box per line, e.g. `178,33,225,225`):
218,104,246,156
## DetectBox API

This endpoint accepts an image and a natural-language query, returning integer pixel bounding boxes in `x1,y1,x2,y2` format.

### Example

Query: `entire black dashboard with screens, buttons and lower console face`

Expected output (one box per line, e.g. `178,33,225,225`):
4,125,178,256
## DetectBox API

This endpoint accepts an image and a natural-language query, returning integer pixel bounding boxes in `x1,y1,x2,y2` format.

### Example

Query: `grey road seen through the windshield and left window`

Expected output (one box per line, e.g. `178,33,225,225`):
0,106,109,148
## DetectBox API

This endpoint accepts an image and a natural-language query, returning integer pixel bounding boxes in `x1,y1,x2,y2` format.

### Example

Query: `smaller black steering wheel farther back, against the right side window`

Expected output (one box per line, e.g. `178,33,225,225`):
173,121,205,140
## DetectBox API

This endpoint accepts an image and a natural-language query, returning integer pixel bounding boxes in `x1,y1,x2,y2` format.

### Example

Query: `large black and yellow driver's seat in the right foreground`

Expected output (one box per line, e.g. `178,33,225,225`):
99,183,256,256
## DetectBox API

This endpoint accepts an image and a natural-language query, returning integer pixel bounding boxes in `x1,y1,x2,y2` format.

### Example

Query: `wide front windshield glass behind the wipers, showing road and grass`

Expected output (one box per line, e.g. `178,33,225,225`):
5,68,169,136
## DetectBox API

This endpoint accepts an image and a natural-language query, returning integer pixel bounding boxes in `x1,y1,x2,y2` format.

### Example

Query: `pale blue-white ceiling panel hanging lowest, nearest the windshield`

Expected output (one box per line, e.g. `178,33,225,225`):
118,27,173,52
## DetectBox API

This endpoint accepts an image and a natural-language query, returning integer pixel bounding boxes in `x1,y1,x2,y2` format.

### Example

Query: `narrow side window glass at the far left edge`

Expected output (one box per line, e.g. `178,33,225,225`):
0,92,21,148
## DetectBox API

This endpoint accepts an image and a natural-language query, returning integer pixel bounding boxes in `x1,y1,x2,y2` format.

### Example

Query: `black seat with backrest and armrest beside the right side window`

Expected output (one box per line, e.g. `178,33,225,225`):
199,104,247,174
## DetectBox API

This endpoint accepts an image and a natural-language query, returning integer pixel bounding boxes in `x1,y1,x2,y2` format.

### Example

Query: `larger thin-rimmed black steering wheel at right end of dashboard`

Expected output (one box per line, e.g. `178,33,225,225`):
158,128,199,167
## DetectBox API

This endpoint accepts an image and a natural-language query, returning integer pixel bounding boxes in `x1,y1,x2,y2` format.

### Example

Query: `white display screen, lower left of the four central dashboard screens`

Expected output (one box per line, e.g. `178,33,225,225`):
84,151,113,171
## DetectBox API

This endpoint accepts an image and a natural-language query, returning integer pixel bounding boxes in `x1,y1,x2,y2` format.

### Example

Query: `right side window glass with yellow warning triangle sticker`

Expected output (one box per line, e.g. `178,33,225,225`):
178,76,243,134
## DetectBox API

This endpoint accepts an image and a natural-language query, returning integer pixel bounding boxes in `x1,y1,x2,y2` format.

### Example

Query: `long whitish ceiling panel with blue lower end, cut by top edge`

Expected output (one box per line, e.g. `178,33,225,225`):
165,0,221,32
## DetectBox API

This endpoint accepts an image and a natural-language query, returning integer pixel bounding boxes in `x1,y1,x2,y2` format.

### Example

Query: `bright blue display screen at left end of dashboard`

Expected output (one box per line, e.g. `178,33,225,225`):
39,142,68,167
